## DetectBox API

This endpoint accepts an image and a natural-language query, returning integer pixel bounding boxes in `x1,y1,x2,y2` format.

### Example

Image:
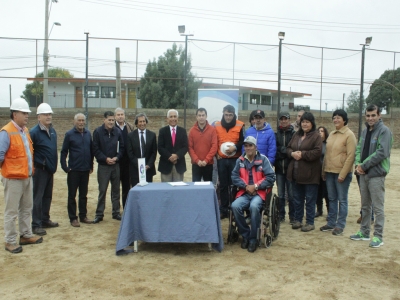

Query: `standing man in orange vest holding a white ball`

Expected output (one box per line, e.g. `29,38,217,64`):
215,105,244,219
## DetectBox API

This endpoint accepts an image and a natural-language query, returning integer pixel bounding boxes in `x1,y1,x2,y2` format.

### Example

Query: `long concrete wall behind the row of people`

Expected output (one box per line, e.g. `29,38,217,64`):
0,108,400,148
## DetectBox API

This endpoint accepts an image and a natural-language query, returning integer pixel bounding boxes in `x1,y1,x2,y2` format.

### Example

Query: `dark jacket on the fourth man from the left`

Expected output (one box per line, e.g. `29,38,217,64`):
93,124,125,165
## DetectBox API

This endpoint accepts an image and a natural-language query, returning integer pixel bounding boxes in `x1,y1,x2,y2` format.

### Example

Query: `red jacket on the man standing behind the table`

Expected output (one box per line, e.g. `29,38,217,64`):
189,122,218,165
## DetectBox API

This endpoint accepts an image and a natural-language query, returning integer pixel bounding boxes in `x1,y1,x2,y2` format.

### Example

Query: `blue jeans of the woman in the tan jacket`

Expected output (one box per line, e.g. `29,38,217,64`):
325,172,353,229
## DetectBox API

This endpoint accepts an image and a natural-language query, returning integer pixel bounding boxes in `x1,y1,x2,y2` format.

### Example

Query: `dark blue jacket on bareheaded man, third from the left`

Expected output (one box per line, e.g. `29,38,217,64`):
60,127,93,173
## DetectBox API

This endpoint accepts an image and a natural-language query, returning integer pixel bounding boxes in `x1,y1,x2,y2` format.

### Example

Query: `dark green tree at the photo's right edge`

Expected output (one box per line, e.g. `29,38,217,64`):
366,68,400,112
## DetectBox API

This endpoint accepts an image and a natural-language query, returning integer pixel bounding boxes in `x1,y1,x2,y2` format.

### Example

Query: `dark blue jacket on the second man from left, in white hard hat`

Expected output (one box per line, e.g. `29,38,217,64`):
29,124,58,174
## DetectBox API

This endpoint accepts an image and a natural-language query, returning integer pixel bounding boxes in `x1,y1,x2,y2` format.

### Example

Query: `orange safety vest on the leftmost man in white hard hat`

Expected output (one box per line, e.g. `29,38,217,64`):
1,122,33,179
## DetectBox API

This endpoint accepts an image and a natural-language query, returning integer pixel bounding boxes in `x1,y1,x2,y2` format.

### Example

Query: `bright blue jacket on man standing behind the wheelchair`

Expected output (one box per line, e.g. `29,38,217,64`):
242,123,276,165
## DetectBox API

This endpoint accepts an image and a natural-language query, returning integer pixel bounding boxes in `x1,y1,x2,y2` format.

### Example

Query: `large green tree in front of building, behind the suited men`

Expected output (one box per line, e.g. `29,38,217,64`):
140,43,201,108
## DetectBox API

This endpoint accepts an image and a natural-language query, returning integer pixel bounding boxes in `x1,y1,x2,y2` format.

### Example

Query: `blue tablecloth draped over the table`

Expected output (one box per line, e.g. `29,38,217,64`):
116,182,224,255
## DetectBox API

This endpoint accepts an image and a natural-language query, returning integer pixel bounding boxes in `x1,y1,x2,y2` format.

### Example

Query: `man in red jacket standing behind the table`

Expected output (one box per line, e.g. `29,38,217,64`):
189,108,218,181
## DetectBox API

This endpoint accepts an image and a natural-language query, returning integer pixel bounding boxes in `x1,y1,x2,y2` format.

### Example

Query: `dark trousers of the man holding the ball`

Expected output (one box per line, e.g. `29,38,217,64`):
217,158,237,215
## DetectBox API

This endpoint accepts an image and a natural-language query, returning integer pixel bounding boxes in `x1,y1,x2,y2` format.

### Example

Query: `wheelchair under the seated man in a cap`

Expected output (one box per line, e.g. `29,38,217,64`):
228,186,280,248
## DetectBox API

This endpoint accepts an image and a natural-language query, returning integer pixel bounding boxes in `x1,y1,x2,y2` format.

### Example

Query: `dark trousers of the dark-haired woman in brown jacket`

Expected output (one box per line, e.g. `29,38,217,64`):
292,181,318,225
